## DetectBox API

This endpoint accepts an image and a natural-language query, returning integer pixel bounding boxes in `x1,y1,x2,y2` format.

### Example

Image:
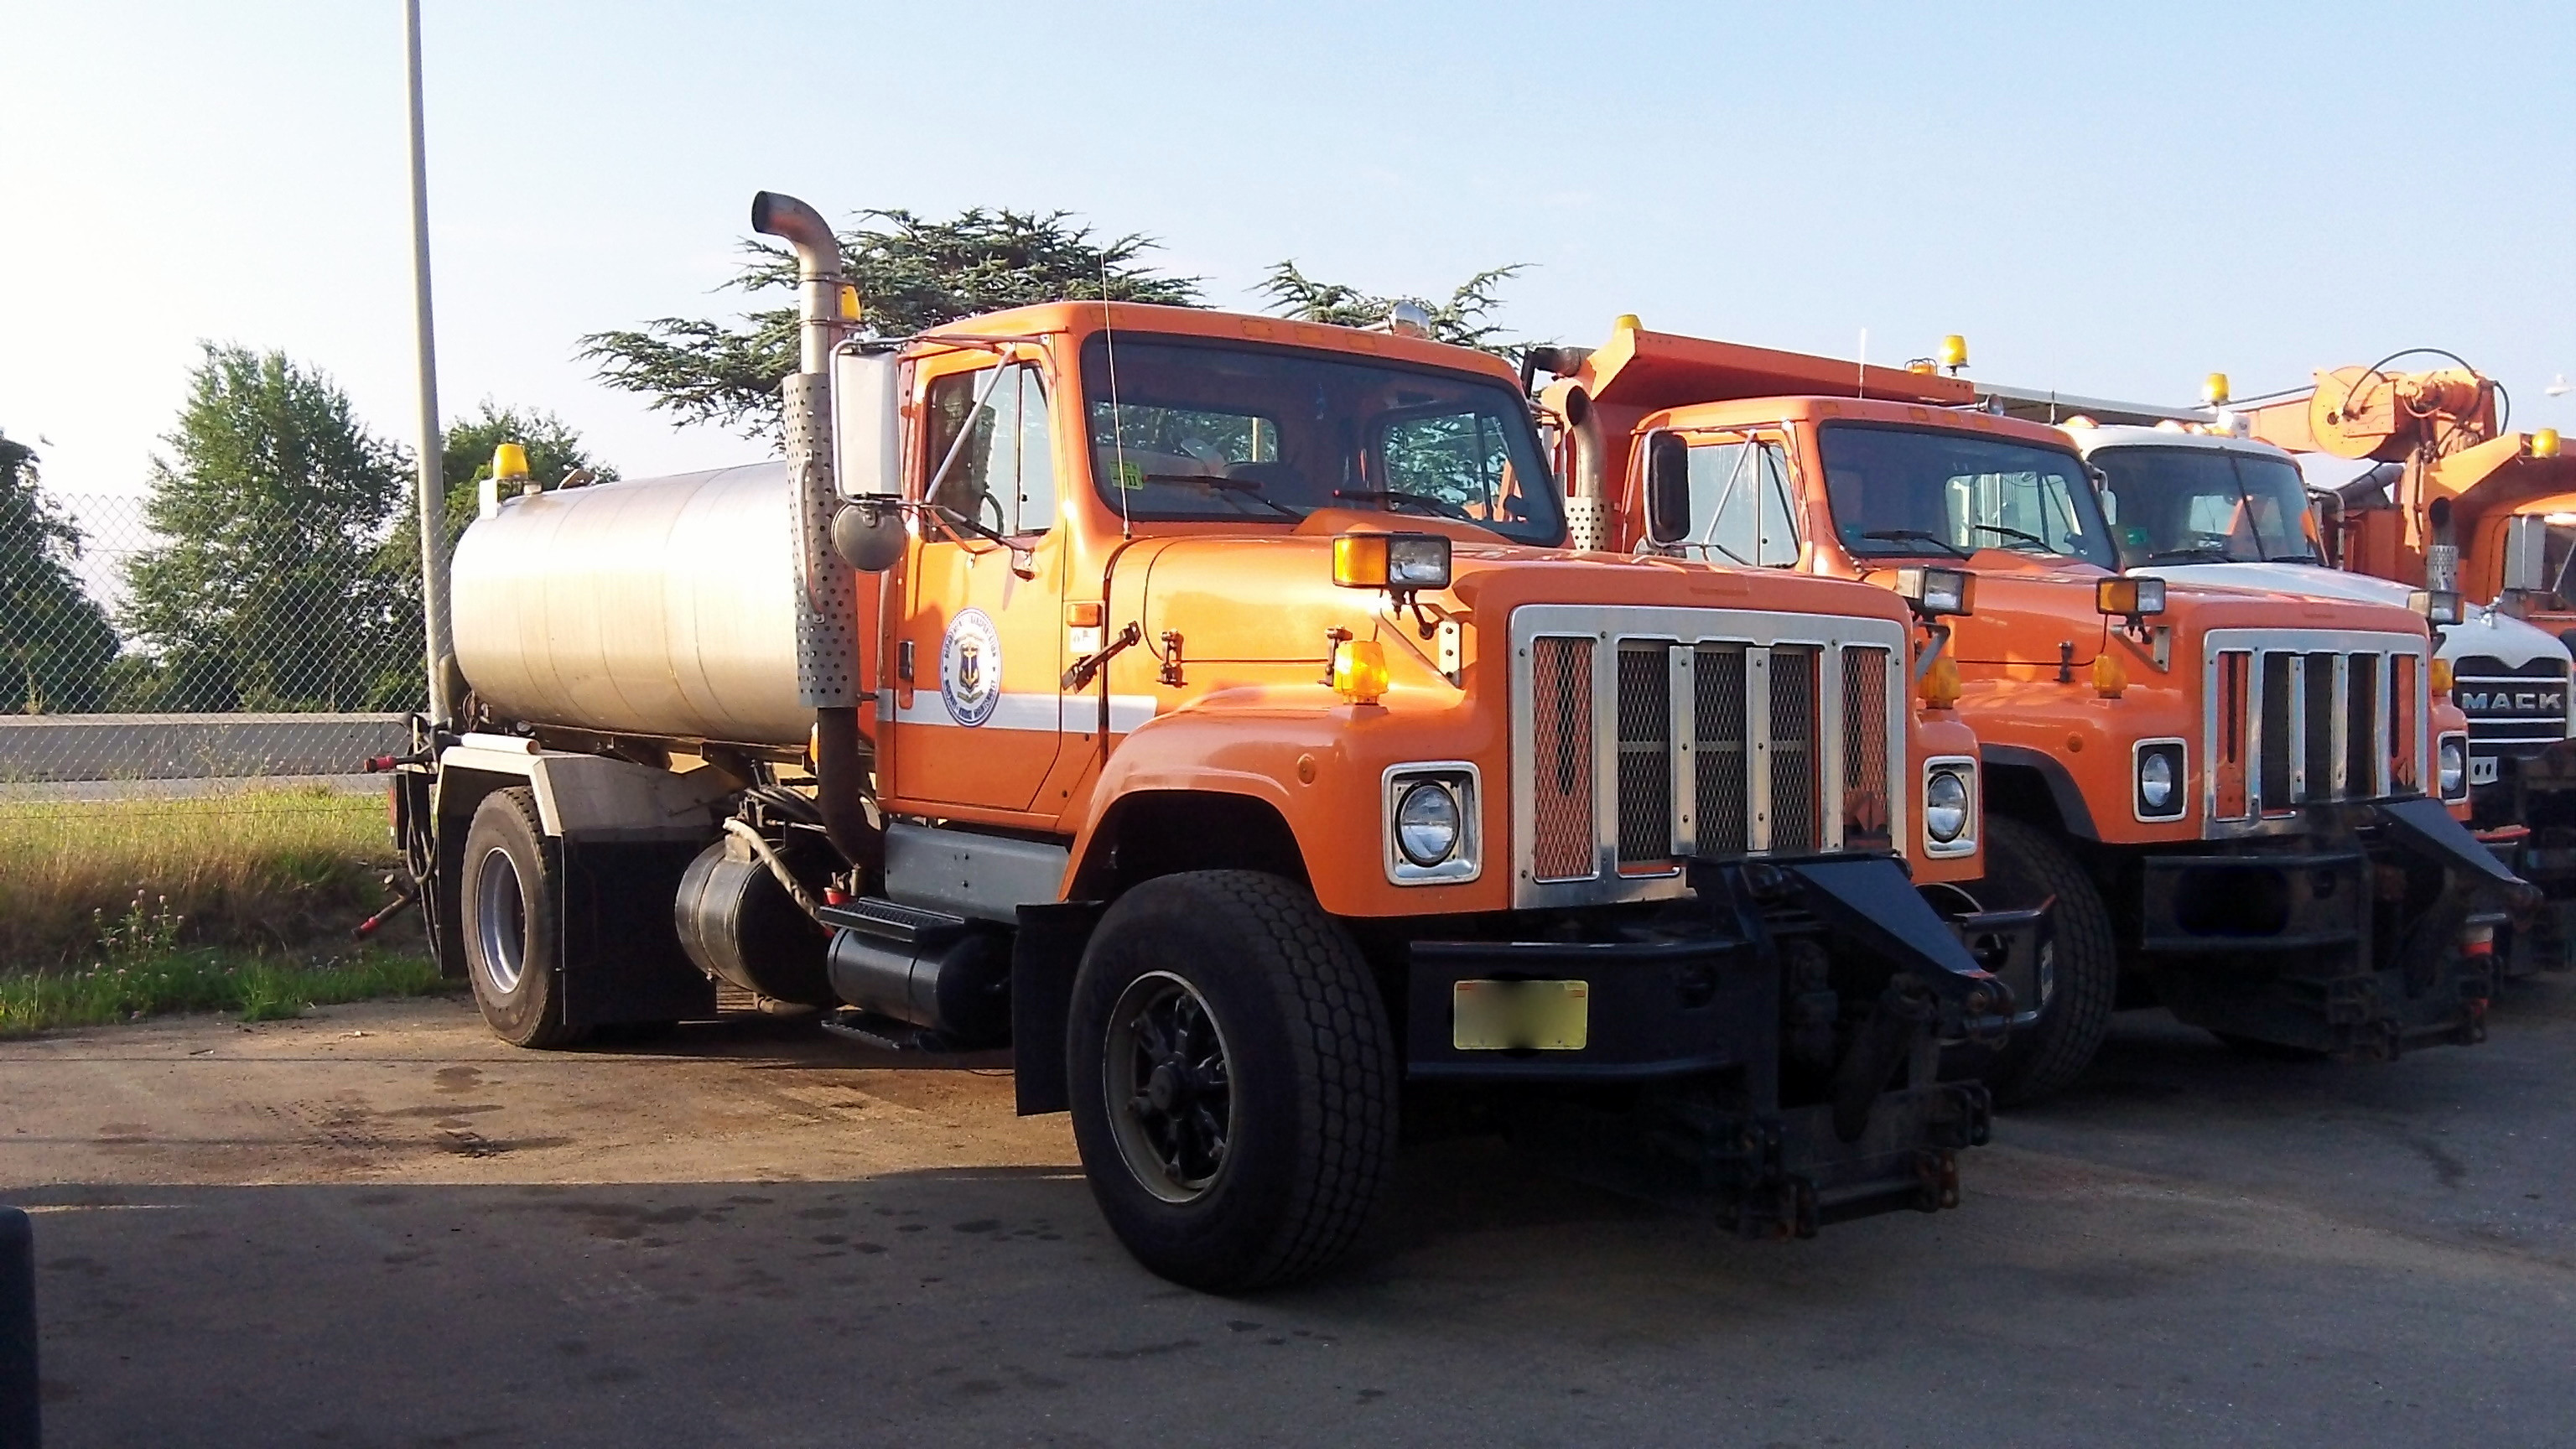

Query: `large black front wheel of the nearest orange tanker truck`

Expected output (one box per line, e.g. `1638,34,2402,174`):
1067,871,1396,1291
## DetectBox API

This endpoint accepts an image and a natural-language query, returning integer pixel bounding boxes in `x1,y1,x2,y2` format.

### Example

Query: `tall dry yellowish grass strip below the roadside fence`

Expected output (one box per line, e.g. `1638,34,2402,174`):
0,789,399,963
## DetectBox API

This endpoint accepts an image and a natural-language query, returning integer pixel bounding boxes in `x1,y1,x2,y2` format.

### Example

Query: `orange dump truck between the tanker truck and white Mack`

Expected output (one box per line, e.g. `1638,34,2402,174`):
1533,317,2494,1101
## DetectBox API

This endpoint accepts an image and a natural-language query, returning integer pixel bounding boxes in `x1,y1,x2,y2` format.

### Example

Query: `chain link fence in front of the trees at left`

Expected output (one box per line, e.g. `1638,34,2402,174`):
0,487,420,813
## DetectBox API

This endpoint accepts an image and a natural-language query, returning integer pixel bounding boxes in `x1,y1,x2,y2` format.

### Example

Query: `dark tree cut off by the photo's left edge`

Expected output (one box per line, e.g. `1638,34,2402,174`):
0,434,116,714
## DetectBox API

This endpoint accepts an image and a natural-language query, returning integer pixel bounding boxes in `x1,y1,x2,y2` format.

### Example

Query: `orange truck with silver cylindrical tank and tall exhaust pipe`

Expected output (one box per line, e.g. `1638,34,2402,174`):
387,194,2040,1289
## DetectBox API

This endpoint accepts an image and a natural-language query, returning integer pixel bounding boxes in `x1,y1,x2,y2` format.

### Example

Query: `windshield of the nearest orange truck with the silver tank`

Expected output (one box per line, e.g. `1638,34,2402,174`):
1082,333,1564,544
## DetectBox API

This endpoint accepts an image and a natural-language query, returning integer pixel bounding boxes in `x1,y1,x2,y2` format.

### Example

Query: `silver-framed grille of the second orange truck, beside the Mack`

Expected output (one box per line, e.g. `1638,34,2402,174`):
2199,629,2429,830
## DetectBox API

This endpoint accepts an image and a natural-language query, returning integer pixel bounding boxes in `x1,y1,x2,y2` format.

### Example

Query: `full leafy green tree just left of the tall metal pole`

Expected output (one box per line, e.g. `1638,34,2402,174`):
121,343,420,709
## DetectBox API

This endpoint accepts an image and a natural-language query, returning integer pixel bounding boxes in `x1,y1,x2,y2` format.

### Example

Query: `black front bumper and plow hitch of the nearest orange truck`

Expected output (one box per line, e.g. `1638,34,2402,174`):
1404,859,2045,1235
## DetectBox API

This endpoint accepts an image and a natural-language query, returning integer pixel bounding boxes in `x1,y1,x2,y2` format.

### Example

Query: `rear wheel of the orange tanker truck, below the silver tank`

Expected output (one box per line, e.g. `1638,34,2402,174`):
459,787,582,1046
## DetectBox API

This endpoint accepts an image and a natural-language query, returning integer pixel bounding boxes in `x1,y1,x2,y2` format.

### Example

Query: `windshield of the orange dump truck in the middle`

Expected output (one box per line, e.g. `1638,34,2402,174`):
1819,423,2115,567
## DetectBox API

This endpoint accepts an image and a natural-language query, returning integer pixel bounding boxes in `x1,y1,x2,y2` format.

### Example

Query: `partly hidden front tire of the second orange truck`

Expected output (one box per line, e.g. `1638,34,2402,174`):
1976,818,2120,1106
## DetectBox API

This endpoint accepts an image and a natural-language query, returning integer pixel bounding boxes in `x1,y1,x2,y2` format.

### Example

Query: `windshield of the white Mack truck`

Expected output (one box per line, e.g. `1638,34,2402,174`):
2091,446,2321,567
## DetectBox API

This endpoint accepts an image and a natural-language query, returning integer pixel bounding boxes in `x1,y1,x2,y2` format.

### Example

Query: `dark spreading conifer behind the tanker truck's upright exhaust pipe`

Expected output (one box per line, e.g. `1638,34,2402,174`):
579,206,1201,436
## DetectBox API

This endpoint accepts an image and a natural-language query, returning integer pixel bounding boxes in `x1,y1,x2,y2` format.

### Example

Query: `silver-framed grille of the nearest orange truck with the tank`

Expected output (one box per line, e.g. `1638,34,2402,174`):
1512,606,1909,905
